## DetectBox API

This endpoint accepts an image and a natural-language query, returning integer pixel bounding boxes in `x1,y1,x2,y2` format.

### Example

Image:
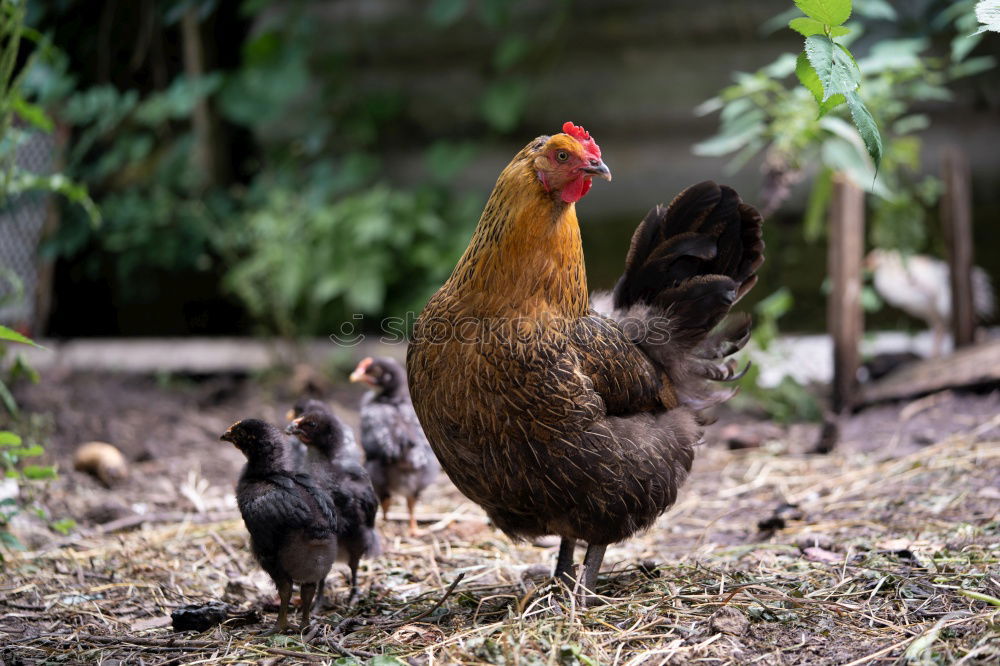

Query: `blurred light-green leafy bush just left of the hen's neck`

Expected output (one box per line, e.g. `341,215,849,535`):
226,185,471,335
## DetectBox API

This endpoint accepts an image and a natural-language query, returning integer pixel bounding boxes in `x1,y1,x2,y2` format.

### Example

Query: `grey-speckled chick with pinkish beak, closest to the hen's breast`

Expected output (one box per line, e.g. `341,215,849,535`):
351,357,441,536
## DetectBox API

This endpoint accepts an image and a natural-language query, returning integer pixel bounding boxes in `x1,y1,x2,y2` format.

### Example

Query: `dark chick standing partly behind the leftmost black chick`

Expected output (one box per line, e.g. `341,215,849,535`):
286,404,381,602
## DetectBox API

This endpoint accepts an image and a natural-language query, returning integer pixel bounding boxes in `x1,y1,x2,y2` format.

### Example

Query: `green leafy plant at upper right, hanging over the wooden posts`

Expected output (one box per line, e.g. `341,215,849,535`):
694,0,995,251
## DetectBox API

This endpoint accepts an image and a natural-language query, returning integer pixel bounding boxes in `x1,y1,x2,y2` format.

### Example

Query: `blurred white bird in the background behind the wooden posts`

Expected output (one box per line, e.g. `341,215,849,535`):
865,249,996,356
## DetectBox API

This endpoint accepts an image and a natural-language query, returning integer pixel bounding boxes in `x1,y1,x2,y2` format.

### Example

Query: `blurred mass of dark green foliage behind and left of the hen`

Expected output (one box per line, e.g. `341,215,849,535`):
28,0,569,335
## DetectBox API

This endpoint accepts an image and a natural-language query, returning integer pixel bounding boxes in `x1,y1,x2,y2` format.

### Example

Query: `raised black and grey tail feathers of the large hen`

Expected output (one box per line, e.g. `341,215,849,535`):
600,181,764,409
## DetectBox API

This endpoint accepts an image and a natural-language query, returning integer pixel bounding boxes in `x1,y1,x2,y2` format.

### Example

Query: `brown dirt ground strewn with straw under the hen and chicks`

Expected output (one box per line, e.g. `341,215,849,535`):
0,373,1000,665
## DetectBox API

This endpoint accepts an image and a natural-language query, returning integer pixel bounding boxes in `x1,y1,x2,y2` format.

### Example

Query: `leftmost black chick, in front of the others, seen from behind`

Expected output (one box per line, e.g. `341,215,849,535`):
220,419,338,634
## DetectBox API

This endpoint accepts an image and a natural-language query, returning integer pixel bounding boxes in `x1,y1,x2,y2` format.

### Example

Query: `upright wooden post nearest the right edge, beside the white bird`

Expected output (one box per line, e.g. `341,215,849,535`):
941,146,976,349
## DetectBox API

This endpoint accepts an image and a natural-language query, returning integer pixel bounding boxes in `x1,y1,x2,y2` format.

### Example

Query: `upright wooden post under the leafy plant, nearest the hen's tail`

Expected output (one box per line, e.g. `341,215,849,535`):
827,174,865,414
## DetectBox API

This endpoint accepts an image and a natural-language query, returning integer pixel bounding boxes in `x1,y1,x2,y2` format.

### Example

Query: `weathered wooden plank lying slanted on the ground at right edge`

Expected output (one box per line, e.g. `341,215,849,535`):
860,340,1000,404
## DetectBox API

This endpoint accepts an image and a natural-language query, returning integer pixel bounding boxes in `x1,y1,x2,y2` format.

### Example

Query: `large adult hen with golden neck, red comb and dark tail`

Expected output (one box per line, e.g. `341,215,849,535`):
407,123,764,591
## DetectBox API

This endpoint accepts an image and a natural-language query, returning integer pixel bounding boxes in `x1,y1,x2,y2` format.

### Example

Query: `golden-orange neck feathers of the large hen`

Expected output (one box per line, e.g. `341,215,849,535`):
444,145,589,317
